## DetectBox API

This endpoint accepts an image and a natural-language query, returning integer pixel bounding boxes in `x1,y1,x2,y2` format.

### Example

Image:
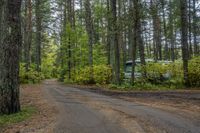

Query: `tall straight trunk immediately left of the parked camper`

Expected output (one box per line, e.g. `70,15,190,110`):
110,0,121,84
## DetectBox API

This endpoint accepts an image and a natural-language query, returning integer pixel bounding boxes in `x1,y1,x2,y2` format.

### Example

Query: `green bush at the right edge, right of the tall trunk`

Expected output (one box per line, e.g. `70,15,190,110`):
188,56,200,87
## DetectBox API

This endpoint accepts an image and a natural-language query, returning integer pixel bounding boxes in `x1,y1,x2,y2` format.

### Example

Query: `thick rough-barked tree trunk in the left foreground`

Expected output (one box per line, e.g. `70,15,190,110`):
0,0,21,114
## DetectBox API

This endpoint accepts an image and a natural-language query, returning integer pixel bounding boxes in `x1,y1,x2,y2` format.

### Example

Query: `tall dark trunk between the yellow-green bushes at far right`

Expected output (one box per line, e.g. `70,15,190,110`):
180,0,189,86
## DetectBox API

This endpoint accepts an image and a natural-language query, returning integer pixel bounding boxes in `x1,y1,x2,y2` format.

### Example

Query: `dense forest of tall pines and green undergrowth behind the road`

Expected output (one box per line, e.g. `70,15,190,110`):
18,0,200,85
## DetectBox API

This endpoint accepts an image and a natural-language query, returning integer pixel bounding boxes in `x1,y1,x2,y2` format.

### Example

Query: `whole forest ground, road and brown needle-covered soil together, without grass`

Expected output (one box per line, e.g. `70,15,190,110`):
0,80,200,133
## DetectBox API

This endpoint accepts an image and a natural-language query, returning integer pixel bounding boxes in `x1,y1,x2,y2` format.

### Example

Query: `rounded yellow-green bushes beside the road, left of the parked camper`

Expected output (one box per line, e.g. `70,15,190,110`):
65,65,112,84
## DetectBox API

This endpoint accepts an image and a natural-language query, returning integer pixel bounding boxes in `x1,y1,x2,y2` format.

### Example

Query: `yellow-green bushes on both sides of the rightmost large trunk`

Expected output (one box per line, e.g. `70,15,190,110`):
146,57,200,88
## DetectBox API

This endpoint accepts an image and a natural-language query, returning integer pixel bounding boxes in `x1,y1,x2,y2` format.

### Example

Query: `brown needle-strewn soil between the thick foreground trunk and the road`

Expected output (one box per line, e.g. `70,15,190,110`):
2,85,57,133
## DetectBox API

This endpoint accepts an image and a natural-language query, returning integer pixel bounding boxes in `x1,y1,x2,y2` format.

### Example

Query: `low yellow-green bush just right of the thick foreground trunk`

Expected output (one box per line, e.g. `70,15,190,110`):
19,63,44,84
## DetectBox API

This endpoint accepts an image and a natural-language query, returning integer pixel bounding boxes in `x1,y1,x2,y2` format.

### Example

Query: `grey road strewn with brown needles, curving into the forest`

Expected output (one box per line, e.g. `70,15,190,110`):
43,80,200,133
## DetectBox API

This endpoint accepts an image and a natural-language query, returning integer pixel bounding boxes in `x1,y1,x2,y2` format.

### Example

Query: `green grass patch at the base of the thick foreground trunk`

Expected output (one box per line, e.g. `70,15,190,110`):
0,106,37,127
